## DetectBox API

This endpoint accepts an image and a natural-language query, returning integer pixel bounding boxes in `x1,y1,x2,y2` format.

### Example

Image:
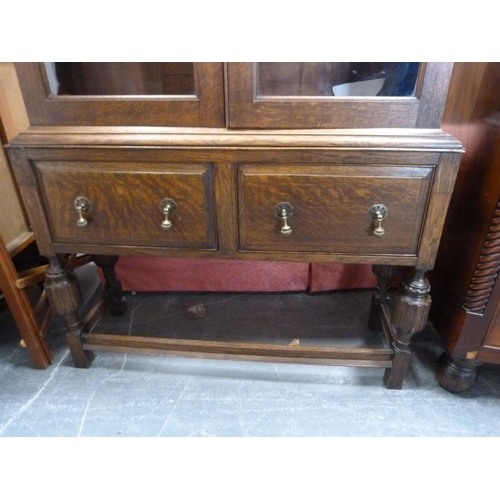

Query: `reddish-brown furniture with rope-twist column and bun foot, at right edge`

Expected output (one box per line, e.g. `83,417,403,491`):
431,63,500,392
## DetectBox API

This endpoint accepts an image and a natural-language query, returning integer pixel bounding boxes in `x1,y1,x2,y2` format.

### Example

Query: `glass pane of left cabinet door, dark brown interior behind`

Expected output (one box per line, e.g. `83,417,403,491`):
45,62,195,96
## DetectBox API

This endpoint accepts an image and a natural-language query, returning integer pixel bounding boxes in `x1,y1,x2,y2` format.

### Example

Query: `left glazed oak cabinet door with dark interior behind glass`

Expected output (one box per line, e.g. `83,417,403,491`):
16,62,224,127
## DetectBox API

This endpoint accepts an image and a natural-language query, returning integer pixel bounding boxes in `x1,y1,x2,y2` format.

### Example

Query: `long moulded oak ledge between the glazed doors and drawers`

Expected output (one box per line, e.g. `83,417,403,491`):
10,126,464,152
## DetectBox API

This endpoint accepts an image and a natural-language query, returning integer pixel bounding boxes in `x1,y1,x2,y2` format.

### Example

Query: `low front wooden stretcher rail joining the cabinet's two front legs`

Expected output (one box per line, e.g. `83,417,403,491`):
83,333,393,368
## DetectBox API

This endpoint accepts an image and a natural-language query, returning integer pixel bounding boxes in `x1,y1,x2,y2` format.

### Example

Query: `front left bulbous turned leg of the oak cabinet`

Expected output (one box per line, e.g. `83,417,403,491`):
45,257,93,368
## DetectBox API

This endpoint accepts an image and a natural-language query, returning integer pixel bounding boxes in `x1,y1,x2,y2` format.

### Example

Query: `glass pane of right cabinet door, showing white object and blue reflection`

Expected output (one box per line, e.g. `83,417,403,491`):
257,62,420,97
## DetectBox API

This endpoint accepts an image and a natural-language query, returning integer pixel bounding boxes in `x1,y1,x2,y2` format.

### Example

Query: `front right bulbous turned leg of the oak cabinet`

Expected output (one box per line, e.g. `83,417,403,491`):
384,270,431,389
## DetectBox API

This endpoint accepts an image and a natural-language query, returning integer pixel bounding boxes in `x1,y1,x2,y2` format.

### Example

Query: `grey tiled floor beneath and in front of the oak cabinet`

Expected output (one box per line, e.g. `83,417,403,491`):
0,264,500,437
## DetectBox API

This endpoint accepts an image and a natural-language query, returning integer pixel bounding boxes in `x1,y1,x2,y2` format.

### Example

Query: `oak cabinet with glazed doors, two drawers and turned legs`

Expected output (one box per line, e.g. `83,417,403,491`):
4,63,463,388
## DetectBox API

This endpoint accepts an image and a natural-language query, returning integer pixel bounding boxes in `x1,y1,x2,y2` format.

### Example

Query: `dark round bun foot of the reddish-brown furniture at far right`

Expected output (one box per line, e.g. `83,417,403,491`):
436,352,481,392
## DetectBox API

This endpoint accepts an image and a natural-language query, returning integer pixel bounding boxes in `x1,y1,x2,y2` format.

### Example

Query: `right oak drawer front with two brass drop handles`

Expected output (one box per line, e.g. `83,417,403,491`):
238,165,433,255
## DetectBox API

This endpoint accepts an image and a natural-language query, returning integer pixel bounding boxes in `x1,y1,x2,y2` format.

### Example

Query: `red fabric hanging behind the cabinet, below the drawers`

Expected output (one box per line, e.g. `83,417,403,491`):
116,257,376,292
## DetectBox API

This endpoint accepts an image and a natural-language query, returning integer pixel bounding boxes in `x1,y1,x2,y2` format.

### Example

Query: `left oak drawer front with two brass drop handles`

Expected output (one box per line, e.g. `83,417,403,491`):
35,161,216,249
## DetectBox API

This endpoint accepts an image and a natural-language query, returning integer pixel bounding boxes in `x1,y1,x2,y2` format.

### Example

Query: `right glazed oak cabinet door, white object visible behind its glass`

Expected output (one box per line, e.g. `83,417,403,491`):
227,62,452,129
